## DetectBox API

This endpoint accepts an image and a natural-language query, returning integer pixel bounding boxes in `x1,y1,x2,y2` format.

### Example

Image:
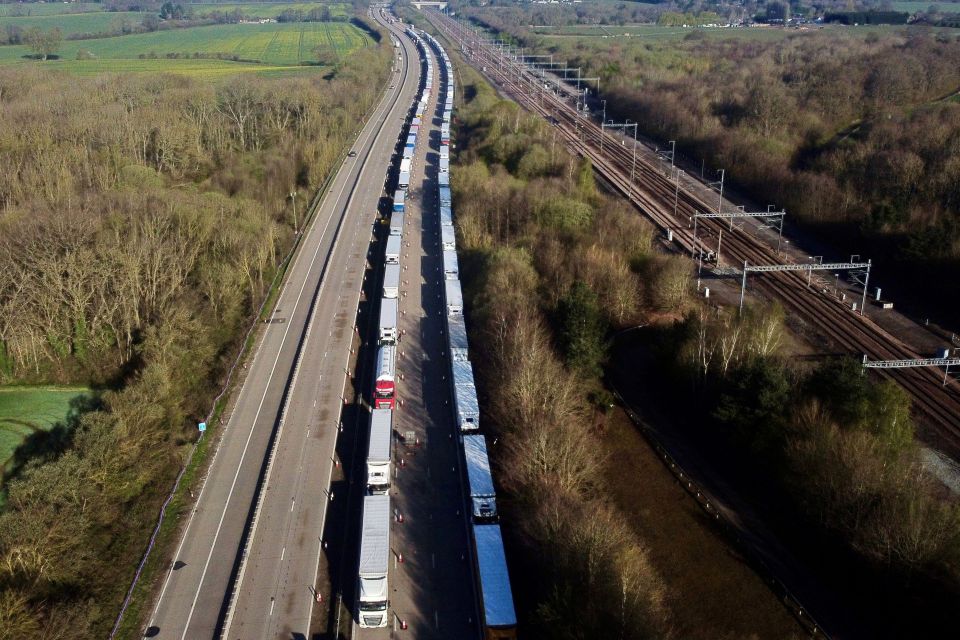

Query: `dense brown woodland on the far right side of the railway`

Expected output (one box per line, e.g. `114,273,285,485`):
466,5,960,316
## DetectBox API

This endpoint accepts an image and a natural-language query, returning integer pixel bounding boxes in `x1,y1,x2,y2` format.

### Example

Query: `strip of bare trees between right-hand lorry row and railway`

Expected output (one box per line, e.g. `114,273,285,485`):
452,47,704,638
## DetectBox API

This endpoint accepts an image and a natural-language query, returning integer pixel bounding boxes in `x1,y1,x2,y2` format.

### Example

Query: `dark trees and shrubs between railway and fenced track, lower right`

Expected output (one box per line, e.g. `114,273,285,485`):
654,306,960,637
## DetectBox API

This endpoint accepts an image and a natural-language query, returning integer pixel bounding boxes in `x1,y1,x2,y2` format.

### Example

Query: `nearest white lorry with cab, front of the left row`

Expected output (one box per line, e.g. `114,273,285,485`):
357,495,390,628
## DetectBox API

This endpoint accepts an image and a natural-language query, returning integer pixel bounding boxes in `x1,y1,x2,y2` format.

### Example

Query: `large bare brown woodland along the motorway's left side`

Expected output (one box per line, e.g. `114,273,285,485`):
0,23,392,639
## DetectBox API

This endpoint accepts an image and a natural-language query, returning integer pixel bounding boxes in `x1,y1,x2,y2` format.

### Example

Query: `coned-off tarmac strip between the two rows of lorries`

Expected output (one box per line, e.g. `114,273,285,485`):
353,22,479,640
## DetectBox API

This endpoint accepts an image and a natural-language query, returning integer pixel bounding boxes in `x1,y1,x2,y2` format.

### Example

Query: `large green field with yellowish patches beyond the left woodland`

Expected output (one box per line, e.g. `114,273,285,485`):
0,22,372,75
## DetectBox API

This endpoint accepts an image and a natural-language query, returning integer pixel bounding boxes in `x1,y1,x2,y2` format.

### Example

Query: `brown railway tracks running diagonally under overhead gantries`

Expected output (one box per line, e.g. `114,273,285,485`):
429,13,960,459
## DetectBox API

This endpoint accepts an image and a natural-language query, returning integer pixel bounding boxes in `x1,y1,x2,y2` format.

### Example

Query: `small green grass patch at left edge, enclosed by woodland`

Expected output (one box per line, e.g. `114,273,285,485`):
0,387,88,476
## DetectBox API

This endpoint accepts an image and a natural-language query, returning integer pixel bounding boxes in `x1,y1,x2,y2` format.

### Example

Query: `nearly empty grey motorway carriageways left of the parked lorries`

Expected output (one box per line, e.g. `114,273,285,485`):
147,20,419,640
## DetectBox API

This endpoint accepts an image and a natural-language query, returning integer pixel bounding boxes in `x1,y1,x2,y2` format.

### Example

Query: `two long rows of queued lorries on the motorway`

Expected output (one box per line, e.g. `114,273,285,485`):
356,17,516,639
